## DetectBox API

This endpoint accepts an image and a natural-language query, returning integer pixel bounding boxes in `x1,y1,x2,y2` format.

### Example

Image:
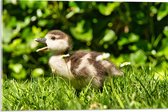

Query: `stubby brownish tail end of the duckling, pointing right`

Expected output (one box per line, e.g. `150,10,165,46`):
101,60,124,76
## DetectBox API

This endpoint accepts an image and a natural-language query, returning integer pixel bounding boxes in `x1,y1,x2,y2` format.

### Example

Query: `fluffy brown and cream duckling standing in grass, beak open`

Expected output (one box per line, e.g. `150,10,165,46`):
35,30,123,90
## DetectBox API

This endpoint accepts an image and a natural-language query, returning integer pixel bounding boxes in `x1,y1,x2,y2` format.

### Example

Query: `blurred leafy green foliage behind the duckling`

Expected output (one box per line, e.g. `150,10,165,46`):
2,0,168,79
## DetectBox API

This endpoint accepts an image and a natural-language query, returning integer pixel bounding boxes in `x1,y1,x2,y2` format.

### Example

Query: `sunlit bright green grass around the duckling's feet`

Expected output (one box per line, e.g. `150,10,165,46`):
2,67,168,110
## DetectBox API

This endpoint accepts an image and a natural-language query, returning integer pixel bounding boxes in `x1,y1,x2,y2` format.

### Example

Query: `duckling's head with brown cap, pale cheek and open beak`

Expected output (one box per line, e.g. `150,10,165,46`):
35,30,71,54
